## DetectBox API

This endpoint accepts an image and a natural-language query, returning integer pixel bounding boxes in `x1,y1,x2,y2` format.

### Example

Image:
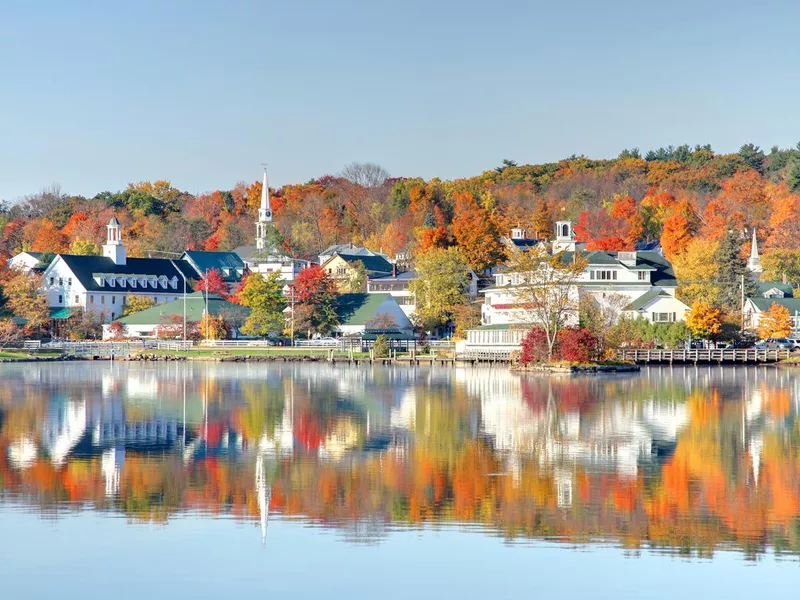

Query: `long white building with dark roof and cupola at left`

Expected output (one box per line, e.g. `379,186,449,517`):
43,217,200,321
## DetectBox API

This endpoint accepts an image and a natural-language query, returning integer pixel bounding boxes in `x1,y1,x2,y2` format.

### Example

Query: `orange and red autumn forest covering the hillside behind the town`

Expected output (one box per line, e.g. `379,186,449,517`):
0,144,800,316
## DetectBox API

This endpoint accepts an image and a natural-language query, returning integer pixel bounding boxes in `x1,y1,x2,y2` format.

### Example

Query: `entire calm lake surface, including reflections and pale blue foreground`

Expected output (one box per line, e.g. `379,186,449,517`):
0,363,800,600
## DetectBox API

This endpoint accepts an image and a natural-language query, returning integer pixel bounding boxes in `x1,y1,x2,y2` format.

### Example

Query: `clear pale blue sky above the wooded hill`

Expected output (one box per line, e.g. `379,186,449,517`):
0,0,800,200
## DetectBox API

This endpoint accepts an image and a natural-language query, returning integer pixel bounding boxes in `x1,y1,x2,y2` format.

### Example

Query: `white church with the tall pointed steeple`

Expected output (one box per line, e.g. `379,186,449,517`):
234,168,311,291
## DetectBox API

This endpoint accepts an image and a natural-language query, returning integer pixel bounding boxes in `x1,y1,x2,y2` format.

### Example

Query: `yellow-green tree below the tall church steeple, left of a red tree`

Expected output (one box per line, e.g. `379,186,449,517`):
235,272,286,337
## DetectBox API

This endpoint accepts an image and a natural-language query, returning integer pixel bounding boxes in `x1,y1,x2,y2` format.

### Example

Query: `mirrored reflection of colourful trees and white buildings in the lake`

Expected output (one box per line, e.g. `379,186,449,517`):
0,364,800,557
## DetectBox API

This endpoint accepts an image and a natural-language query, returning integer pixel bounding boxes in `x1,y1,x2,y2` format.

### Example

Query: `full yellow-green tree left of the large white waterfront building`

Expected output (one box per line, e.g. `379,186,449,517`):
409,247,469,330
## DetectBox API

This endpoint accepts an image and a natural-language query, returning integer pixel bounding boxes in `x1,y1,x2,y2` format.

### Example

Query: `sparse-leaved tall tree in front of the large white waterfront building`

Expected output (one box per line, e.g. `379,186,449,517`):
506,247,589,359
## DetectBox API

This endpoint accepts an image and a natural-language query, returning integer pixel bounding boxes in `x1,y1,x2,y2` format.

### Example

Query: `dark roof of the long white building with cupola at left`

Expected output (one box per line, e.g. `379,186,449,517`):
51,254,199,292
